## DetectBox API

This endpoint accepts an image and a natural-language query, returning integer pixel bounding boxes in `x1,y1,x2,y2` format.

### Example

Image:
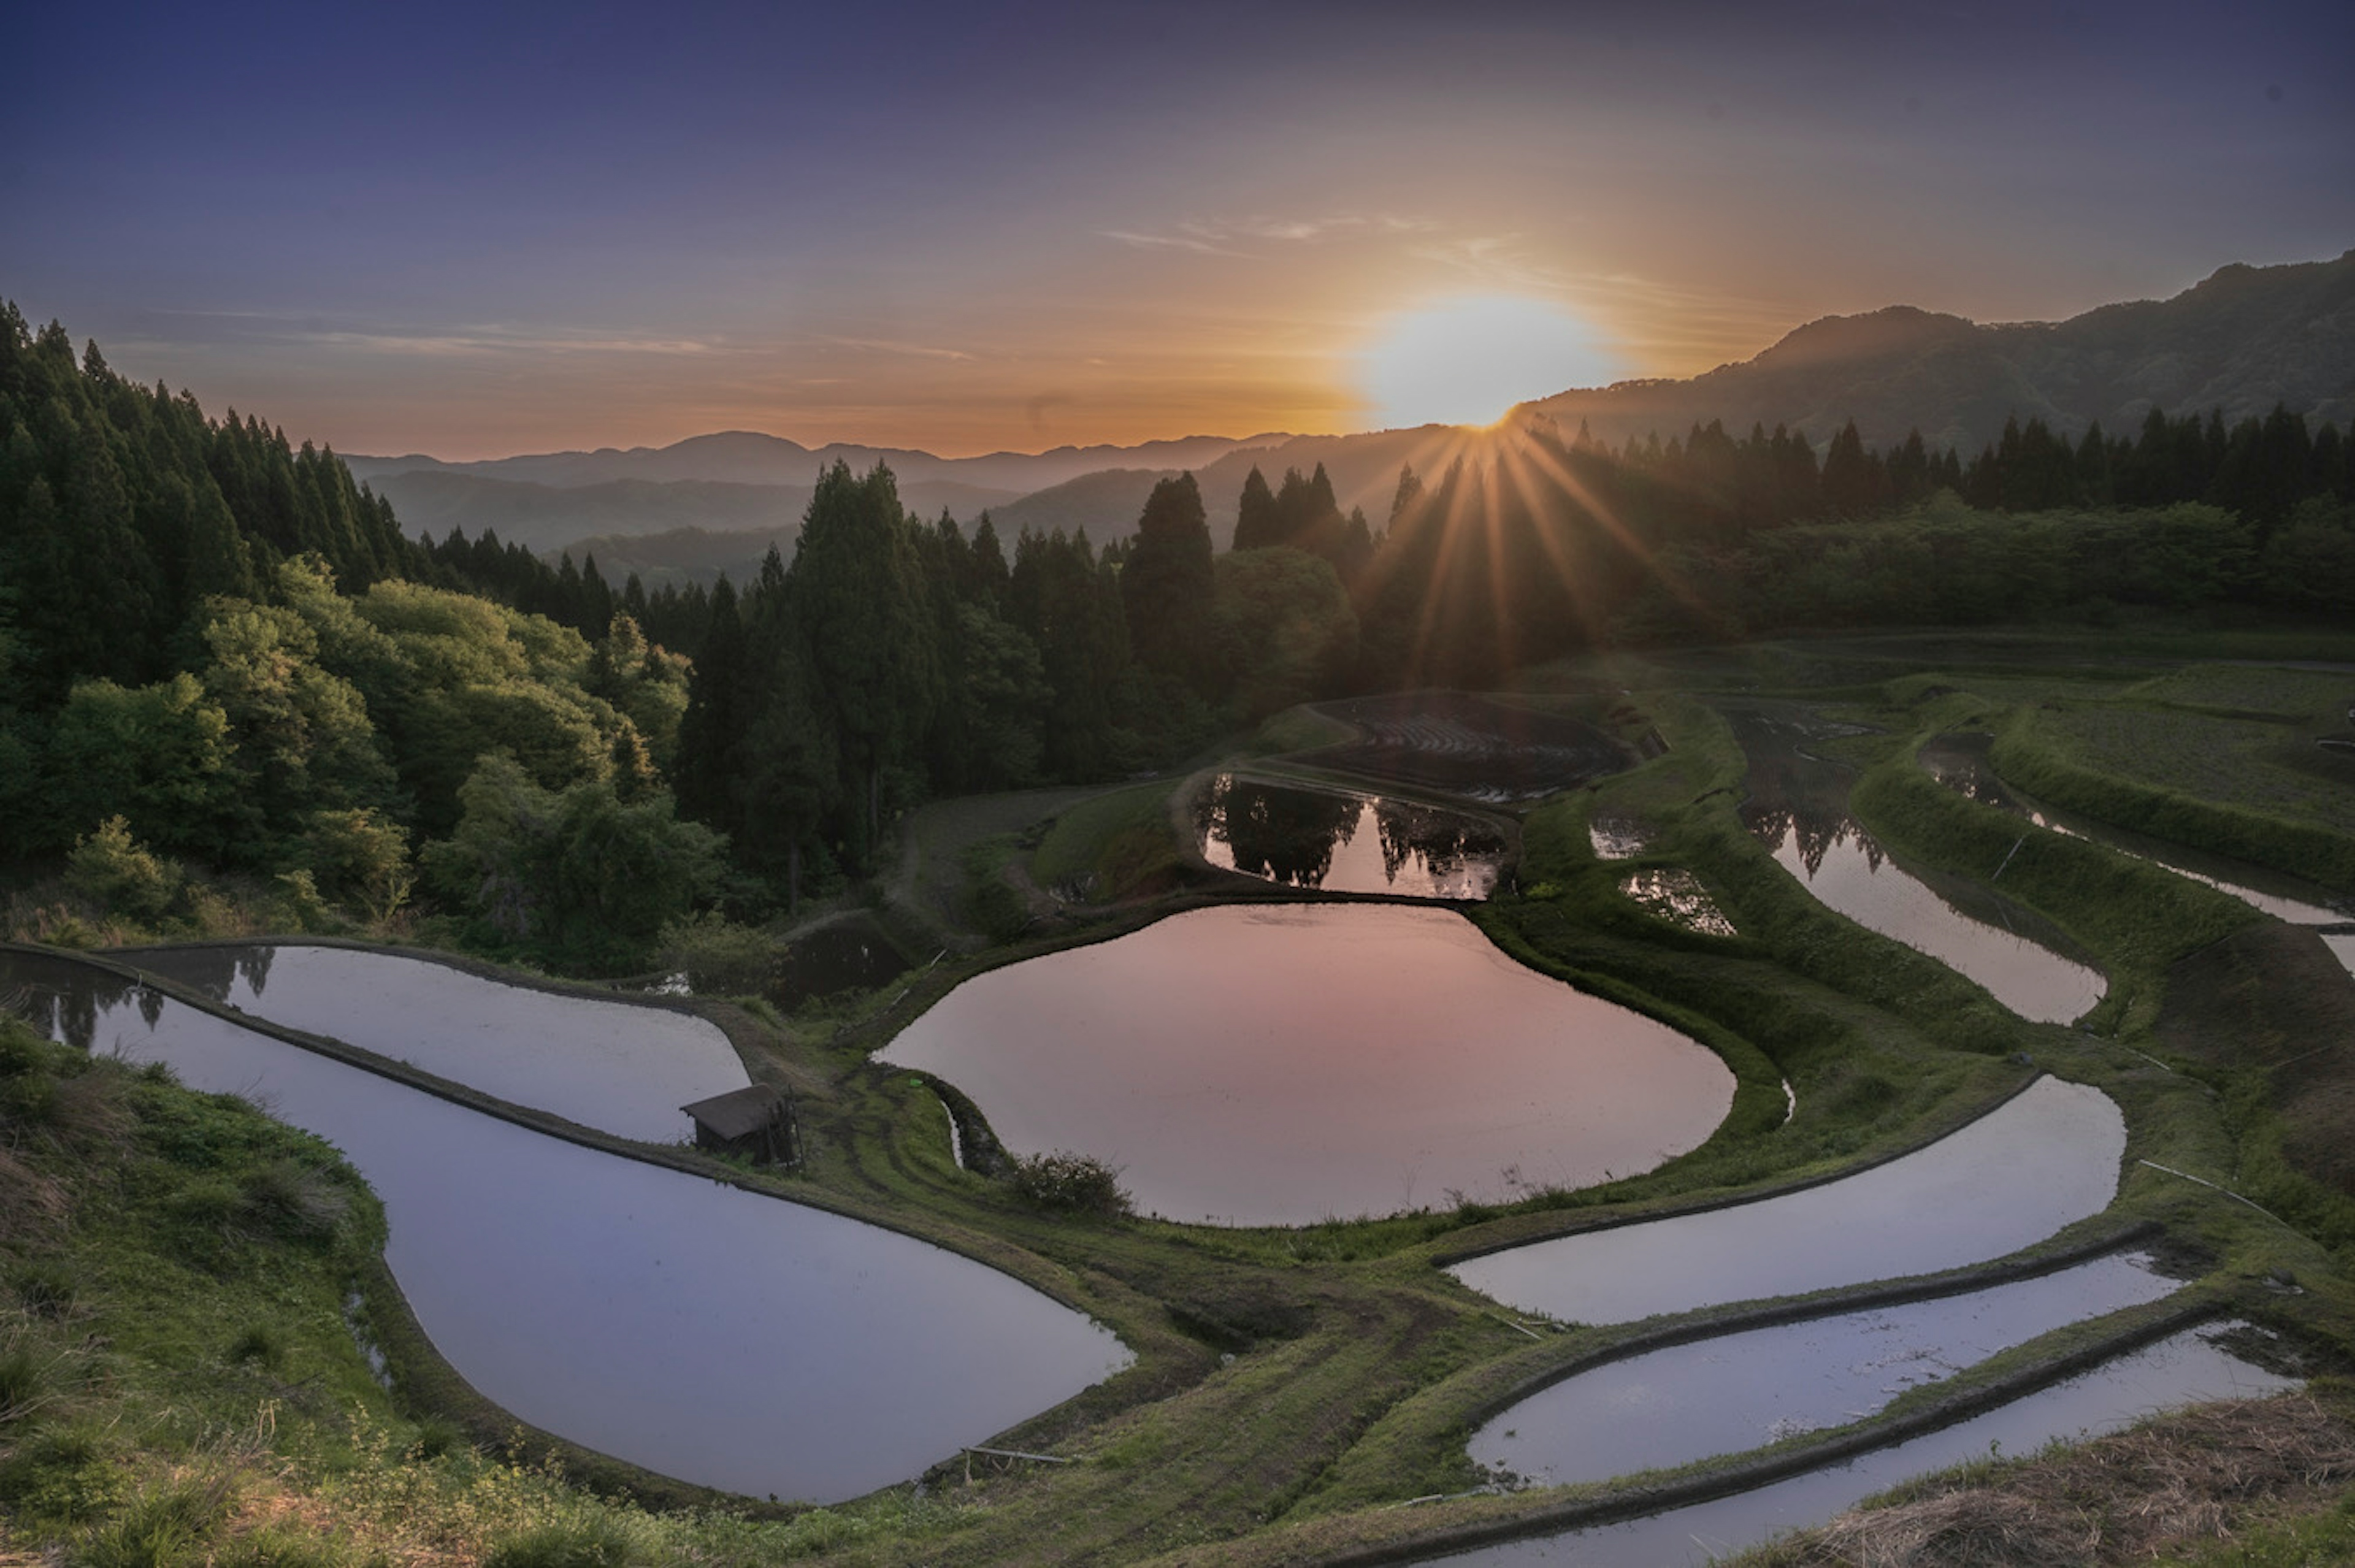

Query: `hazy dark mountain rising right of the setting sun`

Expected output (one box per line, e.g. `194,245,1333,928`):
1517,252,2355,454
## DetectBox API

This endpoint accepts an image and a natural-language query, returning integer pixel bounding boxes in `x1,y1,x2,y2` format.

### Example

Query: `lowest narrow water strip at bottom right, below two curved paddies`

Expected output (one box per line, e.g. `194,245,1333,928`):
1425,1328,2296,1568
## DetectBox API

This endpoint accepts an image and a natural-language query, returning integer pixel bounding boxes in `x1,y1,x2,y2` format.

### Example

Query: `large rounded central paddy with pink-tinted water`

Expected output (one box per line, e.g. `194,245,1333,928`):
881,904,1733,1224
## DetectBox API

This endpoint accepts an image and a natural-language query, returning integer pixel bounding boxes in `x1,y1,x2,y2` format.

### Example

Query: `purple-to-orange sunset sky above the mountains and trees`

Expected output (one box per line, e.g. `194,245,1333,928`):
0,0,2355,459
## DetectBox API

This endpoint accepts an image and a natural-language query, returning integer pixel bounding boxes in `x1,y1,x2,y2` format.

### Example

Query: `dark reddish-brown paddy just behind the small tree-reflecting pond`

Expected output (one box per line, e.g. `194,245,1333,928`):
1300,692,1637,800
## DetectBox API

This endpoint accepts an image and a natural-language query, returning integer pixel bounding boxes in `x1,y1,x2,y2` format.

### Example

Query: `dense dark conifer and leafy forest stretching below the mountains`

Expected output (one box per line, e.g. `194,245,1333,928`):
0,306,2355,970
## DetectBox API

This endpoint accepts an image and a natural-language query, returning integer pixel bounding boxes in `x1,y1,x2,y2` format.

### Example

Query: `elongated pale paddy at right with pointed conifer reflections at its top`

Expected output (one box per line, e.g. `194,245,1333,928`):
1757,813,2108,1024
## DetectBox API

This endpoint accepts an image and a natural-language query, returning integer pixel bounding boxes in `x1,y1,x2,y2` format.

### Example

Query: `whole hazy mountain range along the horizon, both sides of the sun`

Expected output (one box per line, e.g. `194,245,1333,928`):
344,250,2355,572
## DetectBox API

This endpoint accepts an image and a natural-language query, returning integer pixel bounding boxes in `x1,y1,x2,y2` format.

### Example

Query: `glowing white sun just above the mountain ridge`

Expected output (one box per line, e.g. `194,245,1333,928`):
1359,294,1615,429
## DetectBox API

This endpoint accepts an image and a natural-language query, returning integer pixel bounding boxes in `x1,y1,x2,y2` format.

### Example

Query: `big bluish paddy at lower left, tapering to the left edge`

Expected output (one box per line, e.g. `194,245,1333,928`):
0,954,1128,1502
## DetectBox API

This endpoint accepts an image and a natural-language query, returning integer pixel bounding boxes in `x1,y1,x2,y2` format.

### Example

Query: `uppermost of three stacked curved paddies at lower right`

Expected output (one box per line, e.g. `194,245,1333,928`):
1449,1078,2127,1323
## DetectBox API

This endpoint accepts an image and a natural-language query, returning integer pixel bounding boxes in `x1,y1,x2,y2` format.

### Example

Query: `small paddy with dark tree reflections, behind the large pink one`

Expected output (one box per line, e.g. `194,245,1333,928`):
1194,772,1512,900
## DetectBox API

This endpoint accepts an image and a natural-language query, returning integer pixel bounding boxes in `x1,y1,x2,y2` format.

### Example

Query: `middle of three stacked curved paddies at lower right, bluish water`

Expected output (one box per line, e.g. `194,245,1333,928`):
1472,1255,2176,1483
